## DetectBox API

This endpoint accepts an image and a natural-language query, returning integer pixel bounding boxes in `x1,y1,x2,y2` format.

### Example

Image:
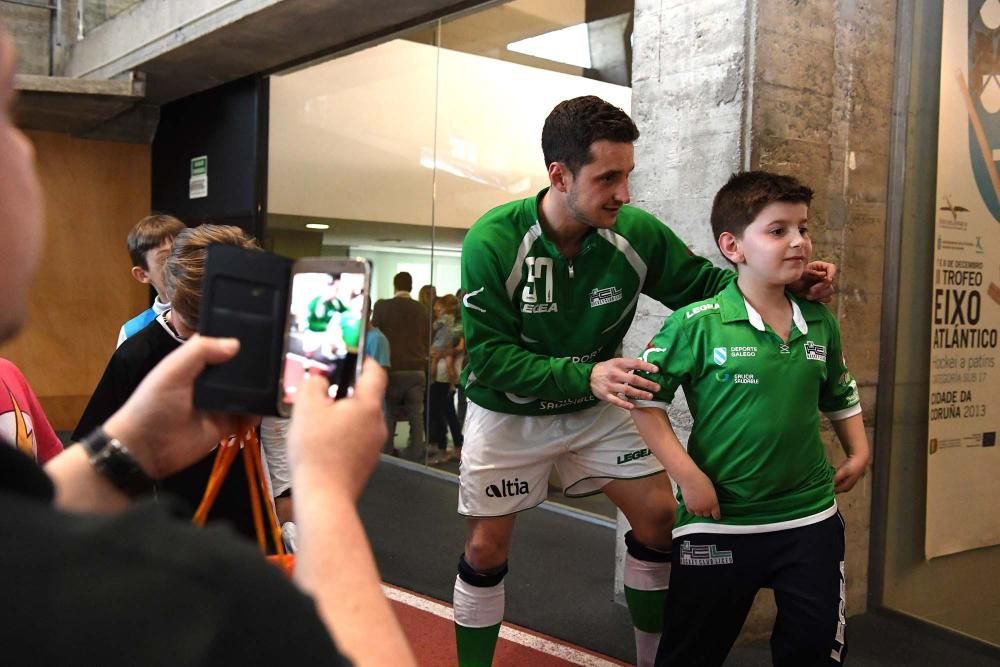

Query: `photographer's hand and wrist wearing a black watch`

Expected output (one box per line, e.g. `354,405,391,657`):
45,336,239,512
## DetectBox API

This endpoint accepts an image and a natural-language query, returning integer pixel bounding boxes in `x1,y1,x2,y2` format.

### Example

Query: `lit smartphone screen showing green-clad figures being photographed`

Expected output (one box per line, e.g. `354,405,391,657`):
278,260,368,414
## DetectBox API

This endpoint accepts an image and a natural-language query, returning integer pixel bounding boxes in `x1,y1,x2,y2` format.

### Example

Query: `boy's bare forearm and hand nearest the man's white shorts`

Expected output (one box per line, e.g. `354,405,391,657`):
632,407,722,520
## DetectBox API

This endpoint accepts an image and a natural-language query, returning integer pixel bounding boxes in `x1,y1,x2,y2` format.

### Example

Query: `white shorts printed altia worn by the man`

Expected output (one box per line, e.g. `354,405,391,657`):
458,401,663,517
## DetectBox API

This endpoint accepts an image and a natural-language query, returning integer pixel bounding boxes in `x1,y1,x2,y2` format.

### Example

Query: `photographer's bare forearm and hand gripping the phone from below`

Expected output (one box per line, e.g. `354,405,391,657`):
288,362,415,666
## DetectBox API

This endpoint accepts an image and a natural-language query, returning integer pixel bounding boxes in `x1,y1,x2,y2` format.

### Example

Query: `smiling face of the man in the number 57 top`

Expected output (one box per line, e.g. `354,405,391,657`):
565,139,635,229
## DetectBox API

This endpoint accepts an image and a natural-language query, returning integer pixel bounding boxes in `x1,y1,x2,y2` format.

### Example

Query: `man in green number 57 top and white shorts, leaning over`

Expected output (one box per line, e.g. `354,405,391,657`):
454,96,835,666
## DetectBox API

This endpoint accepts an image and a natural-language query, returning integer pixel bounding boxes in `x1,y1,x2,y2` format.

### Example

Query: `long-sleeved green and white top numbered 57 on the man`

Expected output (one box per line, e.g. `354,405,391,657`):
462,190,735,415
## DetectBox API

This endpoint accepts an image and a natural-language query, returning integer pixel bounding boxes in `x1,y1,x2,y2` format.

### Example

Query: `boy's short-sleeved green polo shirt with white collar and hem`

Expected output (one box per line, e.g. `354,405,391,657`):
635,283,861,538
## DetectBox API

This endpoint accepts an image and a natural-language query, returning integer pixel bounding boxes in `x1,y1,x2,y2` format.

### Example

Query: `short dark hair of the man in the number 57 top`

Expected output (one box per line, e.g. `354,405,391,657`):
542,95,639,175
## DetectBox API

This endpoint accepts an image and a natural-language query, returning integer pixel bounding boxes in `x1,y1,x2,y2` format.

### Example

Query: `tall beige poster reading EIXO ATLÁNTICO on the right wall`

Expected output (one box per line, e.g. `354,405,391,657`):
924,0,1000,558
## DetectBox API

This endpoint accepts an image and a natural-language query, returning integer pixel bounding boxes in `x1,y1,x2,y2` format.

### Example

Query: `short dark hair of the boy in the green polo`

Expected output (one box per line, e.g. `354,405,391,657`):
712,171,813,243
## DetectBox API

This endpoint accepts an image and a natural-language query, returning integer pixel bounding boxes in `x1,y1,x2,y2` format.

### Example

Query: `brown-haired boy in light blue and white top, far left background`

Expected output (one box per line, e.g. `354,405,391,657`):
115,214,187,347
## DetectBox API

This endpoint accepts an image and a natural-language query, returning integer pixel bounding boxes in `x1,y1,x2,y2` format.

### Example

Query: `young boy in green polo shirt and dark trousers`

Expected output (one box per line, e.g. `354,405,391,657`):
632,171,870,667
